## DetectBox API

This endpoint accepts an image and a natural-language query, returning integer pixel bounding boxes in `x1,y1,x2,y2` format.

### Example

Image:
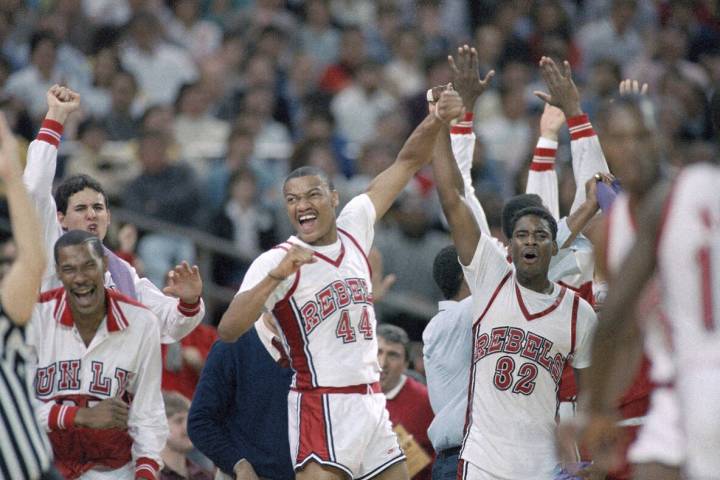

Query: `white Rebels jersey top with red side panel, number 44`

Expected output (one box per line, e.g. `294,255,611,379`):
240,195,380,389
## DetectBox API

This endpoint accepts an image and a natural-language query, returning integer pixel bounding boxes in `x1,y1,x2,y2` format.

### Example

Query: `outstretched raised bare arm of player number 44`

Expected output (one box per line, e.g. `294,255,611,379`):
366,89,462,218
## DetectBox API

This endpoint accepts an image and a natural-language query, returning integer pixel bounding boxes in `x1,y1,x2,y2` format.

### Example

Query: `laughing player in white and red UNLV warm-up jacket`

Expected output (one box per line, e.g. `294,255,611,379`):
27,230,168,480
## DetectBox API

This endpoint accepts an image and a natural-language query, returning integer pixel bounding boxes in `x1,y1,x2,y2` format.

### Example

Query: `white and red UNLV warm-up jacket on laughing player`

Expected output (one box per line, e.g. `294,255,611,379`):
27,288,168,480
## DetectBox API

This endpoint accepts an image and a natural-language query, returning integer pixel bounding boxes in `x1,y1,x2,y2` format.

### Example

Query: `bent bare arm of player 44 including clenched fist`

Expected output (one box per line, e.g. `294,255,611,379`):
218,246,314,342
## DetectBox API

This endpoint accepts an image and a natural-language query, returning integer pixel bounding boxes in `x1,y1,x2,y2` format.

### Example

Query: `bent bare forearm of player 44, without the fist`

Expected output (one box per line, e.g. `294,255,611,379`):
218,275,281,342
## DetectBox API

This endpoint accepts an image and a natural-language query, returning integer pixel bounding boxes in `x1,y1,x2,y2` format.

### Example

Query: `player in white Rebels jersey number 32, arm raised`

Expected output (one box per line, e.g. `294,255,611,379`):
433,91,595,479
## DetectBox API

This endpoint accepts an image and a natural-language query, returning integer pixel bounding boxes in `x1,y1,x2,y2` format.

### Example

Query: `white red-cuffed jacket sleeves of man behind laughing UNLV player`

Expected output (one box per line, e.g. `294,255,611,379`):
23,119,205,343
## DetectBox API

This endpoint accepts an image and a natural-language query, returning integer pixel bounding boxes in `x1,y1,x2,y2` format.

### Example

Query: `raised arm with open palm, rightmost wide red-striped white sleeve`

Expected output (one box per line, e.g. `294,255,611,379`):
535,57,610,213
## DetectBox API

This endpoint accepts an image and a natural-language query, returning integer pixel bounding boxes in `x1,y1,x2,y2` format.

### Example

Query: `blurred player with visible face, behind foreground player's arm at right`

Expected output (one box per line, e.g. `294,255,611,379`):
590,97,684,479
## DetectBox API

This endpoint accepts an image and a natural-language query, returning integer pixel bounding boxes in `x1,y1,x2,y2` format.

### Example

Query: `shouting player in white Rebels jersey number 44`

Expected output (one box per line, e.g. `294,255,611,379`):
218,91,462,480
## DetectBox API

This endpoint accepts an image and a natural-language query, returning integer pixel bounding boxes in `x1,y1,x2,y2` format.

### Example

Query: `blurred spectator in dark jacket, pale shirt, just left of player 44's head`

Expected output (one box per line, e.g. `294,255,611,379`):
207,167,278,288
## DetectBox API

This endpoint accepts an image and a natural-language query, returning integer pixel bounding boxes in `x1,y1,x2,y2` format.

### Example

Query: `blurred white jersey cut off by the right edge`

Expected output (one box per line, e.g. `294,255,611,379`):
658,164,720,370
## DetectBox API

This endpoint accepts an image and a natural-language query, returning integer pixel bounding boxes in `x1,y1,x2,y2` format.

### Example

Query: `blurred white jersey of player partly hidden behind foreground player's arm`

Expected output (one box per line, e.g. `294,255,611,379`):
606,193,675,384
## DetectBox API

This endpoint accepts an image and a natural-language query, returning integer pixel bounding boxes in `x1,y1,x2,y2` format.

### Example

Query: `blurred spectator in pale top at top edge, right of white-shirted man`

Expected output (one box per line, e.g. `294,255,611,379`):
167,0,222,61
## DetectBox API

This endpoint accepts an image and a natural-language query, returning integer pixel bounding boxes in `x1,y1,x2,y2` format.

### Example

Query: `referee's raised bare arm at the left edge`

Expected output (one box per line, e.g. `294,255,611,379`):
0,113,46,325
